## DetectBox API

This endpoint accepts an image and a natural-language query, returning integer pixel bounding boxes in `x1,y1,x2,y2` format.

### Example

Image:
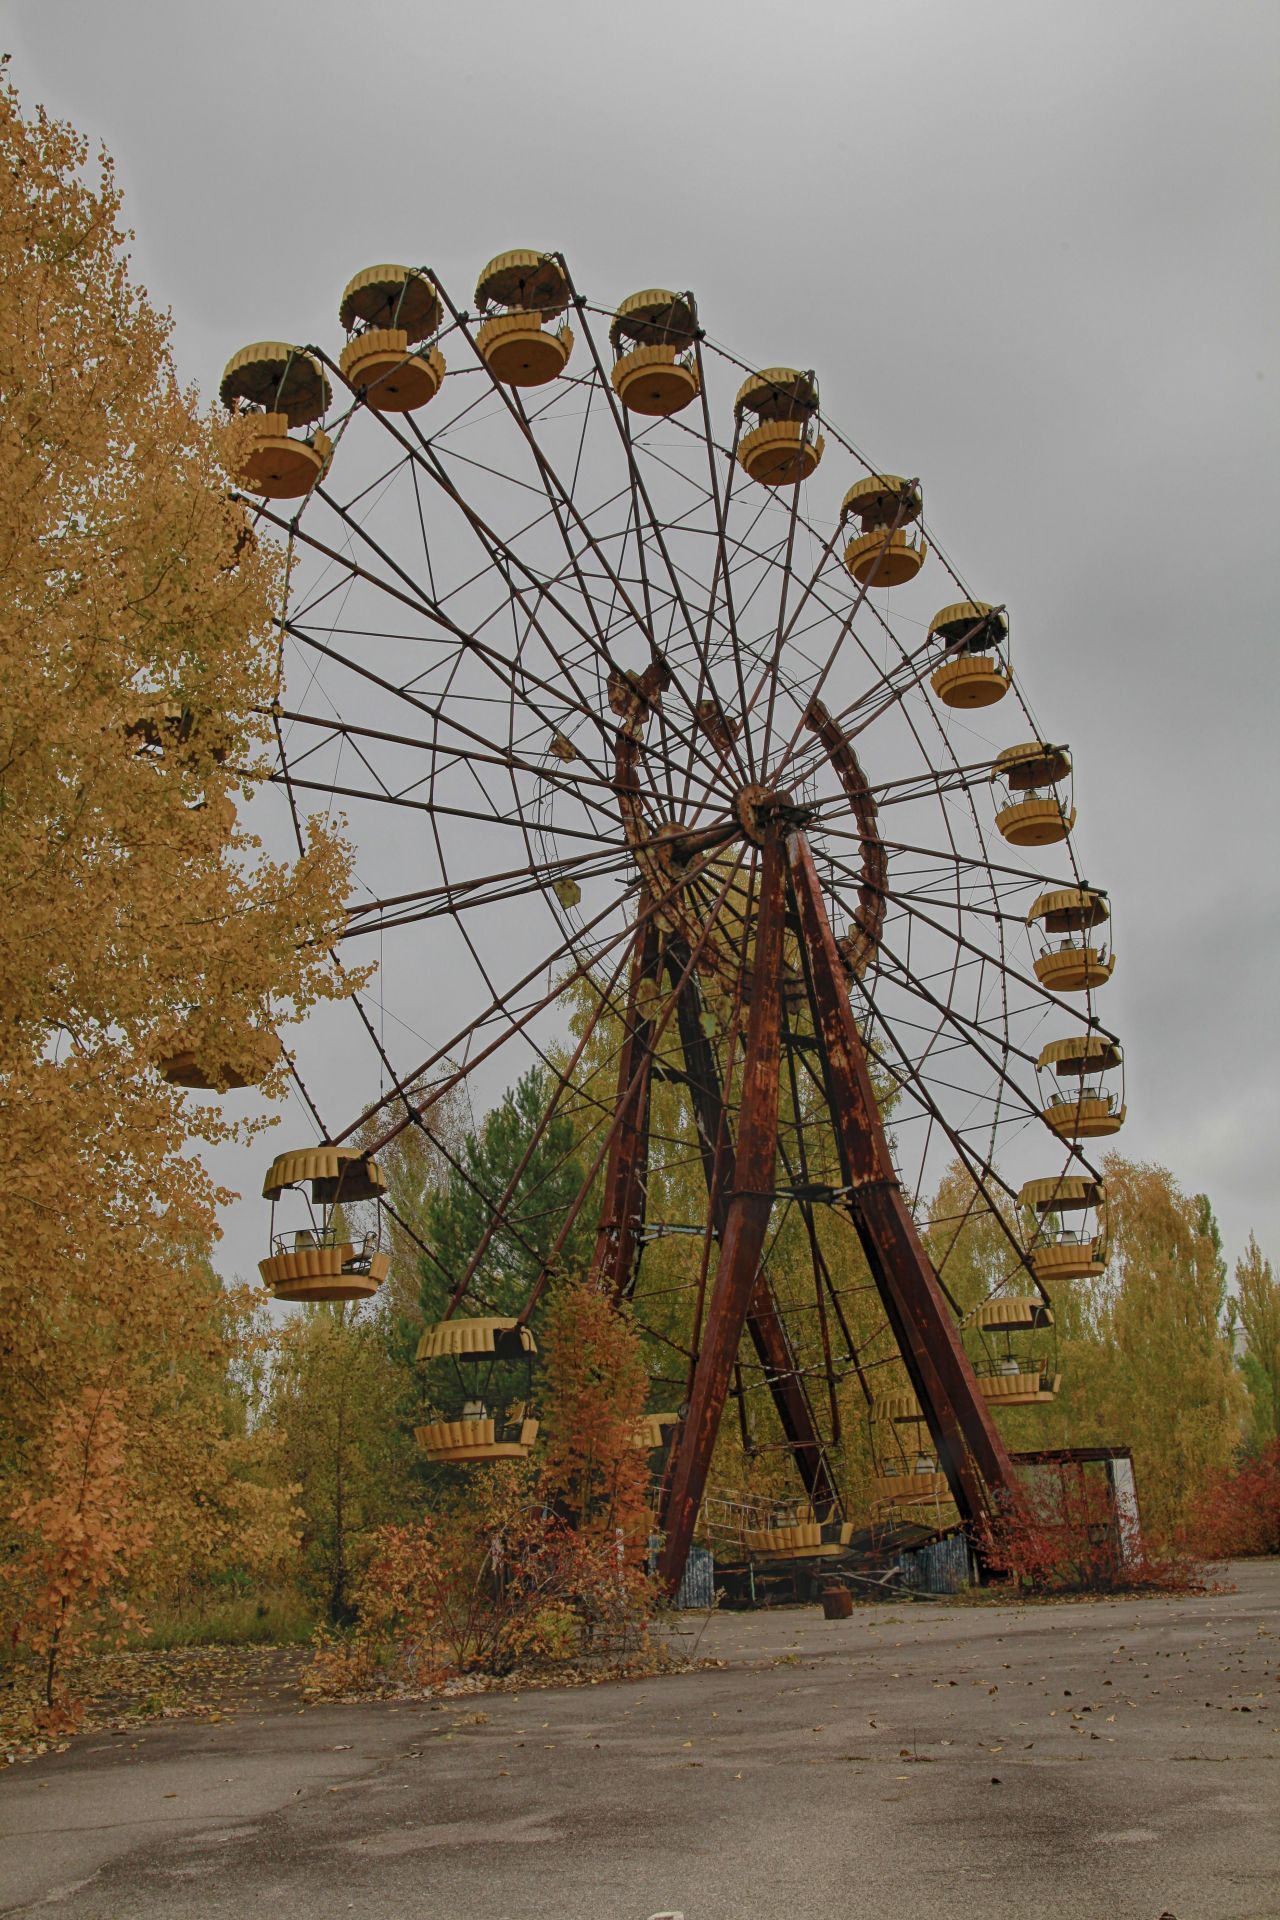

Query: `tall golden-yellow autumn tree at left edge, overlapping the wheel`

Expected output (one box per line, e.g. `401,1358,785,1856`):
0,81,360,1666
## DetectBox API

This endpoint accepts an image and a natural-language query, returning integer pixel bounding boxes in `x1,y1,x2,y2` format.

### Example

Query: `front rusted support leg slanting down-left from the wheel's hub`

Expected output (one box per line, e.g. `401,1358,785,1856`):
658,829,787,1592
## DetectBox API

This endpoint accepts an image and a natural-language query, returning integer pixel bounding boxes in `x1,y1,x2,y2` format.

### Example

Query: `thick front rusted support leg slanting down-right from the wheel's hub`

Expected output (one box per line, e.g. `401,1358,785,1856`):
787,833,1017,1523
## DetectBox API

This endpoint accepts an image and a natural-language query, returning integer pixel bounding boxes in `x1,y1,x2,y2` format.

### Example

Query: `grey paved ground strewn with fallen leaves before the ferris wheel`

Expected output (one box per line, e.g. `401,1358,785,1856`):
0,1561,1280,1920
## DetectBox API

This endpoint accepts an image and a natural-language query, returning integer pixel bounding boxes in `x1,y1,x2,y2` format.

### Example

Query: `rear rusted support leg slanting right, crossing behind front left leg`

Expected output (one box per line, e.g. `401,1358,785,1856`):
676,944,839,1519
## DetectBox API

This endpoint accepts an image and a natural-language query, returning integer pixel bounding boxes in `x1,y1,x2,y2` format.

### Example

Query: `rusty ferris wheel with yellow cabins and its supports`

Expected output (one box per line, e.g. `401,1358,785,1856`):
213,250,1125,1584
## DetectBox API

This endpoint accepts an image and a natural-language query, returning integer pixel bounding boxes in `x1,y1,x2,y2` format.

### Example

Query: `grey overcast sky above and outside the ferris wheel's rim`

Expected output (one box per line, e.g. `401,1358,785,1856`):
12,0,1280,1290
